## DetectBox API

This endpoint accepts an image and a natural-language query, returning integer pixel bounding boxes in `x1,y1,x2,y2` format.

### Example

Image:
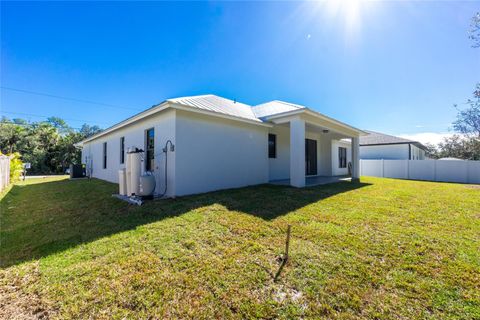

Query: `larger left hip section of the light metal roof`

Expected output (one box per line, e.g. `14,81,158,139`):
167,94,262,122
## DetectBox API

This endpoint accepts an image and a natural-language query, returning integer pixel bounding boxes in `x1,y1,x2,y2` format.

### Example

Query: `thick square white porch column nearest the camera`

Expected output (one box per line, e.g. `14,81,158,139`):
290,118,305,188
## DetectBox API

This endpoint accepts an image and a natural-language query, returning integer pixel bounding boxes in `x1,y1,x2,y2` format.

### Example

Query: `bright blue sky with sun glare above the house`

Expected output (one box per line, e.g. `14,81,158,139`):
0,0,480,142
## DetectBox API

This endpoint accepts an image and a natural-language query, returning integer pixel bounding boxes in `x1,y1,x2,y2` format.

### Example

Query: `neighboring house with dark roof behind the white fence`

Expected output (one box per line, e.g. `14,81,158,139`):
360,130,427,160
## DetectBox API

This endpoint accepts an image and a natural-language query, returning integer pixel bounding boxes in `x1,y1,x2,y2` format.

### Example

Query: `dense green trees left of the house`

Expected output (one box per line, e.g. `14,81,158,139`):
0,117,102,174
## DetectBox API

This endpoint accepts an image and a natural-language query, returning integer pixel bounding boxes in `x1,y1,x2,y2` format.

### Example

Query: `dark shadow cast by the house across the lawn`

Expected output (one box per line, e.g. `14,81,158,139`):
0,179,369,267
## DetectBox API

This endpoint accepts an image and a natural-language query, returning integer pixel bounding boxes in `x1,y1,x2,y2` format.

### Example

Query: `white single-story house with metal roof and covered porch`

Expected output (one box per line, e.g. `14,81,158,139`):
79,95,364,197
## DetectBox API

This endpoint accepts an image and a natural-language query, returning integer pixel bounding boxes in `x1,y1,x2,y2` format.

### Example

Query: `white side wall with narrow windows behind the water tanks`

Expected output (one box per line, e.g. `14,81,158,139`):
82,110,176,195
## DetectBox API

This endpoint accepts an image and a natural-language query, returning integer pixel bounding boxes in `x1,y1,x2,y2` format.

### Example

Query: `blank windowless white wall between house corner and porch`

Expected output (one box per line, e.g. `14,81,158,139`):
175,111,268,195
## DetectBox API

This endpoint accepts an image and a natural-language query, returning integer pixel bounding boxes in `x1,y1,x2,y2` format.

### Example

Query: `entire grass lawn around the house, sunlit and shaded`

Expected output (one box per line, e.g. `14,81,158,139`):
0,178,480,319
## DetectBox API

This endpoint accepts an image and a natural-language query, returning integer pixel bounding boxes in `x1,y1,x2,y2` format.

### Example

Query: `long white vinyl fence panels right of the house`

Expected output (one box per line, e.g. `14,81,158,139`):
360,160,480,183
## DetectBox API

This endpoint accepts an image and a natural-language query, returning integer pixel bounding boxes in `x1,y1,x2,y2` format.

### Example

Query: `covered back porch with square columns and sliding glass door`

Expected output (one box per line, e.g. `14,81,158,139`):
268,109,363,188
